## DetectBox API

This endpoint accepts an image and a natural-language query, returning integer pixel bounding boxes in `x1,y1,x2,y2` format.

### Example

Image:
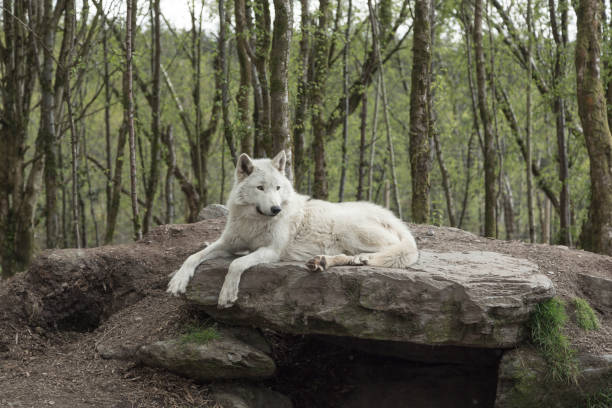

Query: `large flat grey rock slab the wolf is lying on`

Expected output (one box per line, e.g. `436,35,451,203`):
186,251,555,348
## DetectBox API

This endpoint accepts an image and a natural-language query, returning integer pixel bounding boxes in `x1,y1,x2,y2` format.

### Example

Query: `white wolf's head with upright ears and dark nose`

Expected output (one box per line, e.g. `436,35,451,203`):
232,151,294,217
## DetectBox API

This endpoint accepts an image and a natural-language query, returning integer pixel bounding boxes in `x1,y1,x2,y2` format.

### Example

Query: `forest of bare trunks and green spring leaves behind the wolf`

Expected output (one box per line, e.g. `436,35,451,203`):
0,0,612,277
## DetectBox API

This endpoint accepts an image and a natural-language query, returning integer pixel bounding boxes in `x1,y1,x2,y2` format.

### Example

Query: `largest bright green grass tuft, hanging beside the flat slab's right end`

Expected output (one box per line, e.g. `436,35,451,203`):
530,298,578,383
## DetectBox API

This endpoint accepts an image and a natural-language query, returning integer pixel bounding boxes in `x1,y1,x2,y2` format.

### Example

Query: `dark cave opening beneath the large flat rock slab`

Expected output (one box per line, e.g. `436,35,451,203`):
266,336,501,408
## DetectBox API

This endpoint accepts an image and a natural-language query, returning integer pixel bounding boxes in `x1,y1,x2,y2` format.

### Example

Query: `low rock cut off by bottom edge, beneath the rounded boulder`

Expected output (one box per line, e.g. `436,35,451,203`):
211,384,293,408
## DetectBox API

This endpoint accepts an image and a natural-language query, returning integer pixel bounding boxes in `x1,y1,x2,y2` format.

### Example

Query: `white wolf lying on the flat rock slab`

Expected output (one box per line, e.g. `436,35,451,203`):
168,152,419,308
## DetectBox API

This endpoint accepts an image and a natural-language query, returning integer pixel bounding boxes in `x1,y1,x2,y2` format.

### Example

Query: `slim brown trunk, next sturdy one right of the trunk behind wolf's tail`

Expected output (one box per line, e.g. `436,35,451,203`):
474,0,497,237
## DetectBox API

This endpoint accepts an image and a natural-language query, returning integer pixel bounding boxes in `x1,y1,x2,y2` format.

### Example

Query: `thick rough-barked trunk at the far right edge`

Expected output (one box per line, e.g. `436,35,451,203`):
576,0,612,255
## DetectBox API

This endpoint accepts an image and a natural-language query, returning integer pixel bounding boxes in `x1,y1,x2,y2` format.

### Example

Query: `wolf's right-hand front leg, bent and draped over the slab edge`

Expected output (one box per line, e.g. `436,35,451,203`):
218,247,280,309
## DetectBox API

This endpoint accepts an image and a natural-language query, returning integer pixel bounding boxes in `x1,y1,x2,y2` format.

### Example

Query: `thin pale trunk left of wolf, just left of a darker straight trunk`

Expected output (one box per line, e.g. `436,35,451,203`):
125,0,142,240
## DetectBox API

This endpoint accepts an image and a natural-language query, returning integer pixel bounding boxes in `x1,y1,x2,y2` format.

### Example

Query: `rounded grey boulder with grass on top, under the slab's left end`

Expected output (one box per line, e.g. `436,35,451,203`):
136,335,276,381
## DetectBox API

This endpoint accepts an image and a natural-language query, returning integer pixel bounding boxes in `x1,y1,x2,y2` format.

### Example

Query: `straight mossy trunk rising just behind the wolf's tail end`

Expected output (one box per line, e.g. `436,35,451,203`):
409,0,431,224
